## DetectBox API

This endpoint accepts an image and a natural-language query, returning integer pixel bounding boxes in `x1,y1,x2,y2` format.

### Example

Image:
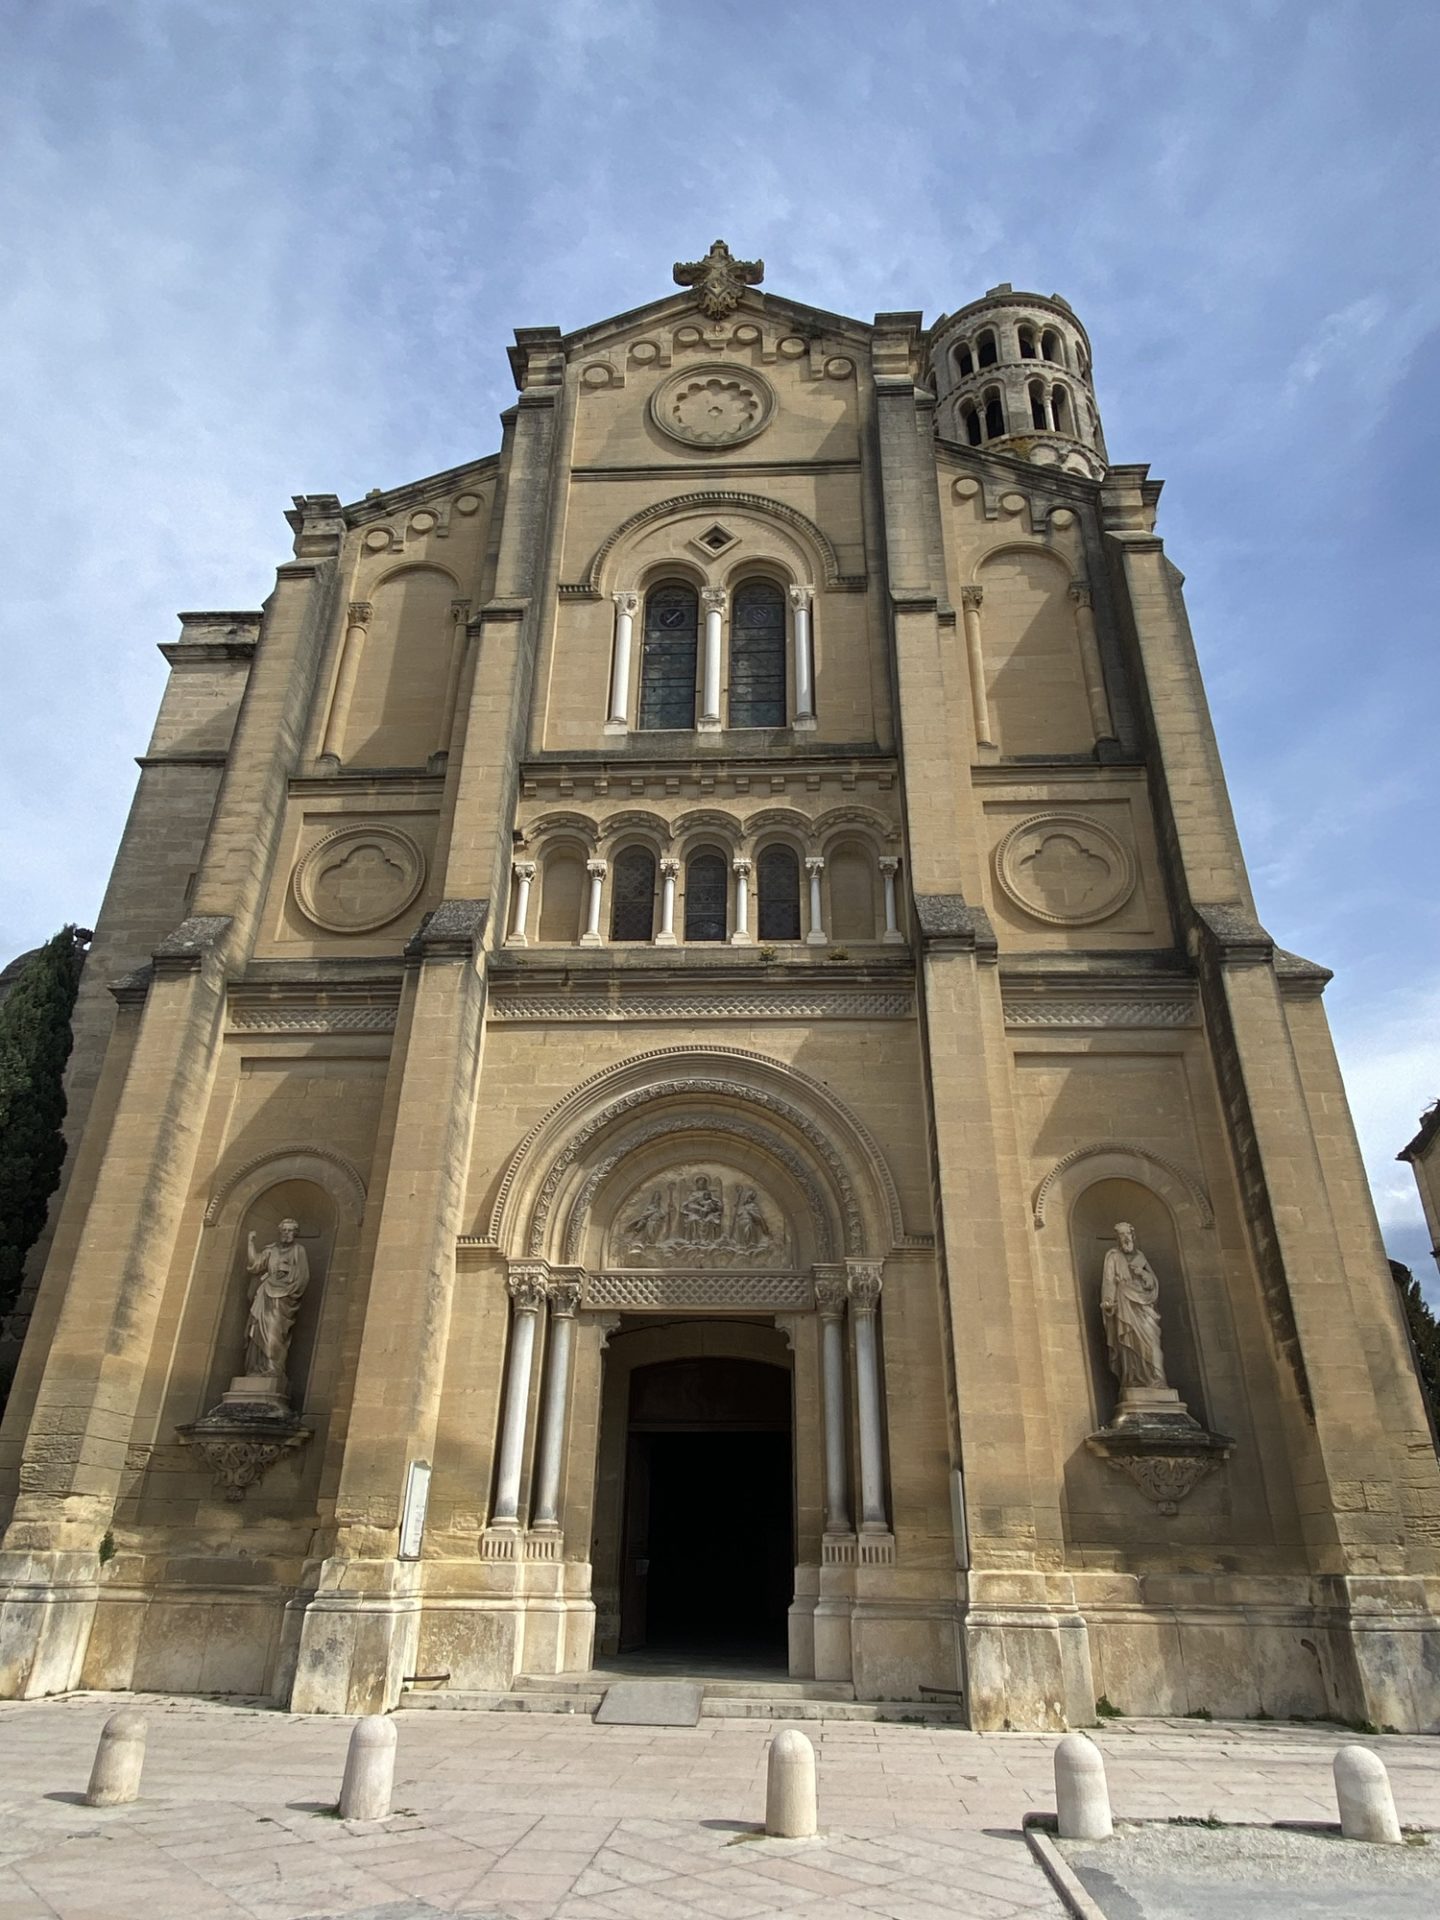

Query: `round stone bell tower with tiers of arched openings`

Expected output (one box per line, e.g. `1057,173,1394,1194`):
929,282,1106,480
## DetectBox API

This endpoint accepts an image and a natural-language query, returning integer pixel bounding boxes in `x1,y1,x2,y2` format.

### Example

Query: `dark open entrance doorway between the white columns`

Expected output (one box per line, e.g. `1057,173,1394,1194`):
620,1357,795,1661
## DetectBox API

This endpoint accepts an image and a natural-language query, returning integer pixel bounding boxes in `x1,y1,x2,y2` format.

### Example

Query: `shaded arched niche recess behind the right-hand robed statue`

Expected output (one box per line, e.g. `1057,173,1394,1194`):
1069,1177,1208,1427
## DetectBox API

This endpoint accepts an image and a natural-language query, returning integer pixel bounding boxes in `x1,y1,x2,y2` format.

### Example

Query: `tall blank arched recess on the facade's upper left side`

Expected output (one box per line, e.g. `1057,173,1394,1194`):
344,566,459,766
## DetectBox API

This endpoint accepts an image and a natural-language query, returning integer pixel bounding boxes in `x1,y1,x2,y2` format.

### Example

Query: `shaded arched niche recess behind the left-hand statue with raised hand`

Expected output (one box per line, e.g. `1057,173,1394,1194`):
194,1148,365,1413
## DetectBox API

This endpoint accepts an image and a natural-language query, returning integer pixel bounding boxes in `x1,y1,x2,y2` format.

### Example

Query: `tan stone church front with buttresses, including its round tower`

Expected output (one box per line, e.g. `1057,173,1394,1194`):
0,244,1440,1728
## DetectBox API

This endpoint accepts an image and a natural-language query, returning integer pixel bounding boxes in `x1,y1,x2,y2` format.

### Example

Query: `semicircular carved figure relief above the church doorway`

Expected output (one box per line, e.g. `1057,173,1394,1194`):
609,1169,789,1267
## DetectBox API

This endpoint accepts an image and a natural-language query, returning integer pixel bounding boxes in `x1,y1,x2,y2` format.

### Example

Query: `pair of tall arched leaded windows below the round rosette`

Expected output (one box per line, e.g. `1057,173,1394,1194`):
639,580,785,732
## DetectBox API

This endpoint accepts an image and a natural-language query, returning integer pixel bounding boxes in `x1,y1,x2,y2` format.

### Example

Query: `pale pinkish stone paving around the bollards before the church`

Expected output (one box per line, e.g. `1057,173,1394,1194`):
0,1693,1440,1920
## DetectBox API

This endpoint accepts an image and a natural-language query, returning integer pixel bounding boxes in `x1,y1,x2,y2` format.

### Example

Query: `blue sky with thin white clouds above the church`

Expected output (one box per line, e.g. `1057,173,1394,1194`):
0,0,1440,1277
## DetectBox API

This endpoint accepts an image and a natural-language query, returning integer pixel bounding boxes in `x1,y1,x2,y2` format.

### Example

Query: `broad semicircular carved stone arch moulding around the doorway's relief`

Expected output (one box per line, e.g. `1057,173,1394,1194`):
488,1046,904,1258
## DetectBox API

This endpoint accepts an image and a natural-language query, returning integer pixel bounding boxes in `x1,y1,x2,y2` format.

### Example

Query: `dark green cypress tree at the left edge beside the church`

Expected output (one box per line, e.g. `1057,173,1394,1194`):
0,927,90,1315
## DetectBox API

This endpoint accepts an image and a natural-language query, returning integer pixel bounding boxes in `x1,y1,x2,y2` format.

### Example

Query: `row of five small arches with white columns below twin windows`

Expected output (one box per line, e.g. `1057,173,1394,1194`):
507,808,904,947
